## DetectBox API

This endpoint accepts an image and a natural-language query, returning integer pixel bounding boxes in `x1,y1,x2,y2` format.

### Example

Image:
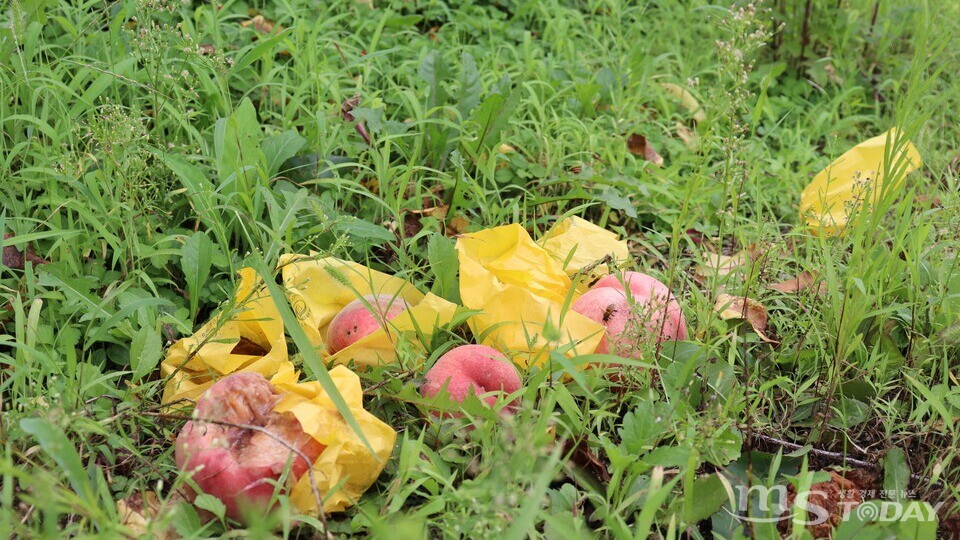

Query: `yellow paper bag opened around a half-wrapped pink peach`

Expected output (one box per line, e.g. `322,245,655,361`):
280,255,457,366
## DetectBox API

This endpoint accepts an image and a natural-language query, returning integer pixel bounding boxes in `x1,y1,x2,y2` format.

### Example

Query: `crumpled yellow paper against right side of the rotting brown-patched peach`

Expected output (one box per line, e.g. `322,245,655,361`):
270,363,397,515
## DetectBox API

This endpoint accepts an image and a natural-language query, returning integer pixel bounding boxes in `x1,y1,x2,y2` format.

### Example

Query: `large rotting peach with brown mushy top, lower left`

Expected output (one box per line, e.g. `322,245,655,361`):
175,373,325,520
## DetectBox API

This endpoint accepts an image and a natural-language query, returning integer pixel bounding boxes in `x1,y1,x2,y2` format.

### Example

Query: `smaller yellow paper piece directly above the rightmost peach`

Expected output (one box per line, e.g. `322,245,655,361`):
539,216,630,286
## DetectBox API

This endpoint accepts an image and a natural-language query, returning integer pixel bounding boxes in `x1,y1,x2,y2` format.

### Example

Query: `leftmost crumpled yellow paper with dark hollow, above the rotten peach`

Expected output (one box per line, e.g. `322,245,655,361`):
160,268,289,403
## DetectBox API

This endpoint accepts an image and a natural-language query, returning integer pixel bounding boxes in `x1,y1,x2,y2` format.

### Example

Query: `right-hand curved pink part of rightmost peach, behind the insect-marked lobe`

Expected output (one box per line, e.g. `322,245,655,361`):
593,271,687,341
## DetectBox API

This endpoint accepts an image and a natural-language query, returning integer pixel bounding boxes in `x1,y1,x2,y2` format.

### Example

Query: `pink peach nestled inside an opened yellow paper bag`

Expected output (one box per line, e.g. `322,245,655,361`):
327,294,408,354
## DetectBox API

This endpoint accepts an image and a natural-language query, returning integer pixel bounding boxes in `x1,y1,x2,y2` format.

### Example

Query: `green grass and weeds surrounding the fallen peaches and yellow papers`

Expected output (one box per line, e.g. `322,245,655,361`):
0,0,960,538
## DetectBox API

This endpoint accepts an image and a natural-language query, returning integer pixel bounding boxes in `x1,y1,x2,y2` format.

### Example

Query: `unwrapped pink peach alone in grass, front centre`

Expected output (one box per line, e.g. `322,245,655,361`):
420,345,520,409
